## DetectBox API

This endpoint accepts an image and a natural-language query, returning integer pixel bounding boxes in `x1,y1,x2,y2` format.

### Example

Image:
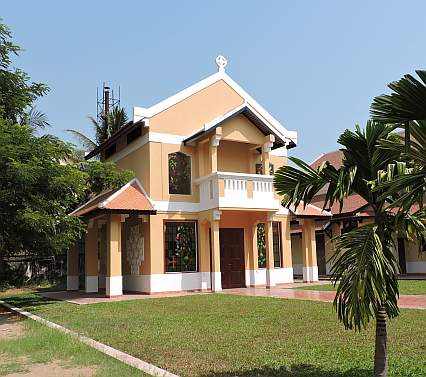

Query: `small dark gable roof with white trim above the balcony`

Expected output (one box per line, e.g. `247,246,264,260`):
183,103,296,149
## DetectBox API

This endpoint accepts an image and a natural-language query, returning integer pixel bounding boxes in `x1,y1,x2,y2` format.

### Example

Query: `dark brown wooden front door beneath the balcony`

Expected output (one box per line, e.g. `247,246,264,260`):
219,228,245,289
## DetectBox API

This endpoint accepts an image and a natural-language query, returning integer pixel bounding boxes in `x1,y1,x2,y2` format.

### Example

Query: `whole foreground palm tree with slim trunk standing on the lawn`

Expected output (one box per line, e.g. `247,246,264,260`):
274,121,406,377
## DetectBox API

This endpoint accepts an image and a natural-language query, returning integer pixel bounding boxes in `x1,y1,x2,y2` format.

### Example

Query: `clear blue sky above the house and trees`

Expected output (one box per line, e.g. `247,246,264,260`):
1,0,426,161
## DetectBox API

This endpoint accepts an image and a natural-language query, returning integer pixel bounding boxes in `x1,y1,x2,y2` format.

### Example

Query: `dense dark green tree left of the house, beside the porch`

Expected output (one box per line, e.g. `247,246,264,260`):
0,118,85,275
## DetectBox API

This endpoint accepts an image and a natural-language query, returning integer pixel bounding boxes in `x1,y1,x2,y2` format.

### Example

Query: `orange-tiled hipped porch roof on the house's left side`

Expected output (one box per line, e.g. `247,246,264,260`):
71,178,157,217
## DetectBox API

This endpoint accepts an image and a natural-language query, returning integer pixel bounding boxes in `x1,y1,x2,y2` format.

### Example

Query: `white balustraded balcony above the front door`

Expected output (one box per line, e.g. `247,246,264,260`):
195,172,280,211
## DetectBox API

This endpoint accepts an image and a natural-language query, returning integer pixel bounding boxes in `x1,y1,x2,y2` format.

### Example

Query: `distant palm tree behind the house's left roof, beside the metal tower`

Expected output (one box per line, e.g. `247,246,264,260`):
66,106,129,151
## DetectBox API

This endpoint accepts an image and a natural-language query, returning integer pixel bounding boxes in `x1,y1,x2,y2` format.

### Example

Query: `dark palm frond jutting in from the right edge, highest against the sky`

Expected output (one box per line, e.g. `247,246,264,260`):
370,70,426,123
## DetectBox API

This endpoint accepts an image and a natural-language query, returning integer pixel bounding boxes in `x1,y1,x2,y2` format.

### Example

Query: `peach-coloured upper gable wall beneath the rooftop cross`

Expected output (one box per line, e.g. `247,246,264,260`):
149,80,244,136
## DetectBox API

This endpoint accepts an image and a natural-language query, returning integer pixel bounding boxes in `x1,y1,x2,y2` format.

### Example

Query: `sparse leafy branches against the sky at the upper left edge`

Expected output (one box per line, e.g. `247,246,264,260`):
0,19,49,123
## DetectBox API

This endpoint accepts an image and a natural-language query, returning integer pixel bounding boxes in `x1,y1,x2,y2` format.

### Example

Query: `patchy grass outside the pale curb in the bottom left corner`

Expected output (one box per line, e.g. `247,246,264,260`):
0,304,148,377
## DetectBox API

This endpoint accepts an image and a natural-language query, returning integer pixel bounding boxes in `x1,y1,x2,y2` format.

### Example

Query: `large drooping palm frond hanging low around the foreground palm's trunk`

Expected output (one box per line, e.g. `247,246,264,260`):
331,224,399,330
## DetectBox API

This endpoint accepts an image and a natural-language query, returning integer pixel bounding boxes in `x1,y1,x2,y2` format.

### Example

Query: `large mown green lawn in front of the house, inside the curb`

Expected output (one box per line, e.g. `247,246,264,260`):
1,294,426,377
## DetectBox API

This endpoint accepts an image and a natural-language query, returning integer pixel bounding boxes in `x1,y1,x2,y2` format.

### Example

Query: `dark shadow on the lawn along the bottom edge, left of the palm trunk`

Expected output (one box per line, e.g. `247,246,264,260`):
202,364,372,377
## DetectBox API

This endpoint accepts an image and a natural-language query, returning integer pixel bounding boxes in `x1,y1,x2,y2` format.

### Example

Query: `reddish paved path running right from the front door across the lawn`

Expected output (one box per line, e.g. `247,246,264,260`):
222,286,426,309
